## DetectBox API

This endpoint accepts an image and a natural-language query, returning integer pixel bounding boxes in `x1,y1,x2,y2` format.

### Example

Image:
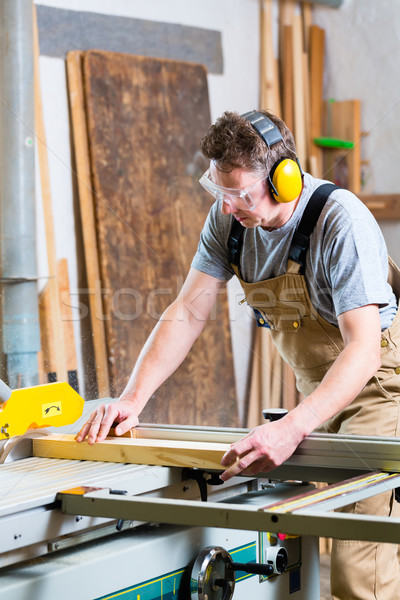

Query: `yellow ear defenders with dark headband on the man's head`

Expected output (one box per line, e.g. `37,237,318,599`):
242,110,303,202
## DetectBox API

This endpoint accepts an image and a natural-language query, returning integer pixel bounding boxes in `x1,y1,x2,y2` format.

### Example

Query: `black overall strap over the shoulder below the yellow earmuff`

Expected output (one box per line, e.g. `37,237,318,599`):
289,183,340,272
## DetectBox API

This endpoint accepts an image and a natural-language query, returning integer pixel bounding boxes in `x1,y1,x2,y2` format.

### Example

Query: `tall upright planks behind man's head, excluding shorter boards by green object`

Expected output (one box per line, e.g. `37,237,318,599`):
260,0,325,175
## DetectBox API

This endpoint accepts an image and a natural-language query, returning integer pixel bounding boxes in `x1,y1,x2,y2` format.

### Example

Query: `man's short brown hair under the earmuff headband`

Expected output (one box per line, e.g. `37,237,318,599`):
200,110,296,174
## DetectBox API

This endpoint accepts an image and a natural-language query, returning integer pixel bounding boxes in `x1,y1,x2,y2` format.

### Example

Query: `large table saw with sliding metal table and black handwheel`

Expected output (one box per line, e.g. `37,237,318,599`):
0,384,400,600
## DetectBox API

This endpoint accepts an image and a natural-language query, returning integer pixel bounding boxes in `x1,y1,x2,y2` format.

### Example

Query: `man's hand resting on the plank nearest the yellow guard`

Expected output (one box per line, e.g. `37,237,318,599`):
75,400,139,444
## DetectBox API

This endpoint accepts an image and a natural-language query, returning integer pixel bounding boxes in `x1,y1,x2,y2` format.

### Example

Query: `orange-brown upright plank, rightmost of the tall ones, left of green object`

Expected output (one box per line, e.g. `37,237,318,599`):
310,25,325,178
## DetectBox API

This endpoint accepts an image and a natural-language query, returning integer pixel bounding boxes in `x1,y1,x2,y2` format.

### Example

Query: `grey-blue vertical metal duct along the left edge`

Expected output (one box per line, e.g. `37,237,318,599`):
0,0,40,388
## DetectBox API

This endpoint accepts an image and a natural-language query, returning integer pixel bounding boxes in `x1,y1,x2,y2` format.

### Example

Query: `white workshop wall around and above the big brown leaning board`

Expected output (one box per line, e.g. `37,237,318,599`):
36,0,259,412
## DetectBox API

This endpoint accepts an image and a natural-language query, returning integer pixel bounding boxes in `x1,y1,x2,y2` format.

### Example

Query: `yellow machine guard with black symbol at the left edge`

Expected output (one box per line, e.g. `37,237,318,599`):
0,382,84,440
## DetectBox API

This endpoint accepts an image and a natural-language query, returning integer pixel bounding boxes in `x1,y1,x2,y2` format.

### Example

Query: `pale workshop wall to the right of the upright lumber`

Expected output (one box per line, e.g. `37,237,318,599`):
313,0,400,263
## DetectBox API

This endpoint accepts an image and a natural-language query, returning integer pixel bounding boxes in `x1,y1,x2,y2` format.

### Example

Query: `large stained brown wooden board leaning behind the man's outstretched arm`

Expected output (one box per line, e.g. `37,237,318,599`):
84,51,237,426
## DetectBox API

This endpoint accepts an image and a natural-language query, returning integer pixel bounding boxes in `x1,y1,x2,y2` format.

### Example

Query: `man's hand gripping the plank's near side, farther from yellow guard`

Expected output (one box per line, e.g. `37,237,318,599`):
221,417,302,481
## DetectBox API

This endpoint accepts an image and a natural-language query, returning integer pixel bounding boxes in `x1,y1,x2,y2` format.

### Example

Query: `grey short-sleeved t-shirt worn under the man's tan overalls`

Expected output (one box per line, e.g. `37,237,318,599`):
192,173,397,330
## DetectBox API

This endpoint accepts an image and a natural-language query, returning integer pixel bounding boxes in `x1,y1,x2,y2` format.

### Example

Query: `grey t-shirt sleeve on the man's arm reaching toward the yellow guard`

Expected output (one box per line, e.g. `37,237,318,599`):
192,203,234,281
